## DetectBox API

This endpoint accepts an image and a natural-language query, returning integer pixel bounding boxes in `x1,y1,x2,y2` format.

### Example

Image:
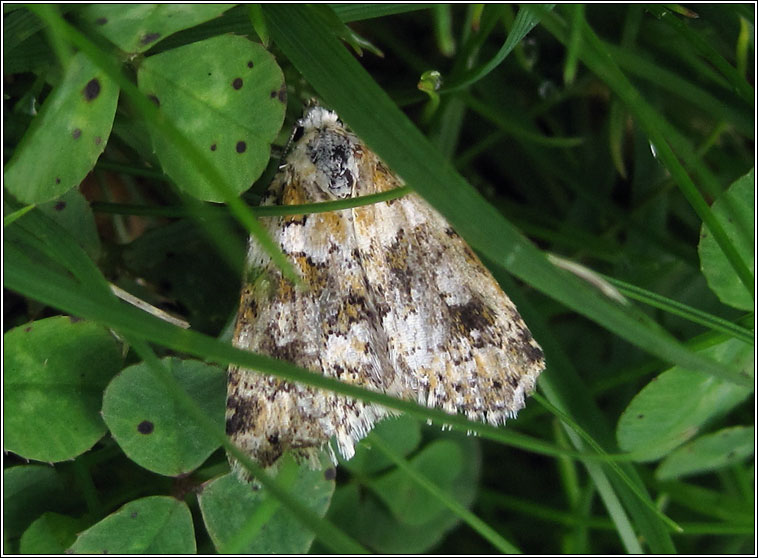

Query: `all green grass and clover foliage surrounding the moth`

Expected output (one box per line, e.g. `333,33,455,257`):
3,4,755,554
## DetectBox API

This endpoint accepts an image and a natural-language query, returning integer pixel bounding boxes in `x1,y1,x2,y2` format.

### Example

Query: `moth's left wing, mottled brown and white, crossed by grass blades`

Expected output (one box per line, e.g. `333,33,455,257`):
226,168,392,477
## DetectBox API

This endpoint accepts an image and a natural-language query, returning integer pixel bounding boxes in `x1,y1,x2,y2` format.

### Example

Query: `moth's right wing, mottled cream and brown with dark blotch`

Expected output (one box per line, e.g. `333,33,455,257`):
353,157,544,424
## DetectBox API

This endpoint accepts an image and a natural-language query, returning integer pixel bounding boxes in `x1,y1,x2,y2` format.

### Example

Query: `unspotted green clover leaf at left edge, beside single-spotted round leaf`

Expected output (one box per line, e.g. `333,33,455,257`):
3,316,121,462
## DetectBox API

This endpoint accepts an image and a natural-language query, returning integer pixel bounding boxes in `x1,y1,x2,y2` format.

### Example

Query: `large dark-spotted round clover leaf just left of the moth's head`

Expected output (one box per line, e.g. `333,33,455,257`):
137,35,287,201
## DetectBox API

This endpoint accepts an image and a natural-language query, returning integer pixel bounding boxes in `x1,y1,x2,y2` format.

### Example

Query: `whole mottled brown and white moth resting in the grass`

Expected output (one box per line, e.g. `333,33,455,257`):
226,105,545,478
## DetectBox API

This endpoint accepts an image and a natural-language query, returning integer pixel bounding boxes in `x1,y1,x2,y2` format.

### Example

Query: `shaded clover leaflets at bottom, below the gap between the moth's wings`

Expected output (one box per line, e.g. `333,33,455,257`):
329,424,481,554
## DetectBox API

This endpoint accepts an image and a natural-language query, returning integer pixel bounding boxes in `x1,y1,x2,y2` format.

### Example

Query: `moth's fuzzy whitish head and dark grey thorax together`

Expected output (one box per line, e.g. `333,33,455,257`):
291,106,358,199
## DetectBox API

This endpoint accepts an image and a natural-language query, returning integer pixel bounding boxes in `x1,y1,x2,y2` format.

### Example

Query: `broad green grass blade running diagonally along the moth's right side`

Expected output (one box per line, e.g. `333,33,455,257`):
264,4,751,385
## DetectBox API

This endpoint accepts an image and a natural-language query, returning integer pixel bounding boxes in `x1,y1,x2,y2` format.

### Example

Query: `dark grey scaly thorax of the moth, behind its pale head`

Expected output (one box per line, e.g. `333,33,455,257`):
306,129,358,199
